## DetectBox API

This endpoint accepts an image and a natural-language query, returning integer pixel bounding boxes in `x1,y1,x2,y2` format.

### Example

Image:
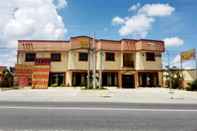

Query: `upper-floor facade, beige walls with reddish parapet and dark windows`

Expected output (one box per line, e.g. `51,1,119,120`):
17,36,165,72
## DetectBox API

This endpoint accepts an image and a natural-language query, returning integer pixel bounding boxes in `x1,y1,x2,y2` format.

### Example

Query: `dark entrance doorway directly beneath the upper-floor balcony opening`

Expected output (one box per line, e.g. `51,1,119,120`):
122,75,135,88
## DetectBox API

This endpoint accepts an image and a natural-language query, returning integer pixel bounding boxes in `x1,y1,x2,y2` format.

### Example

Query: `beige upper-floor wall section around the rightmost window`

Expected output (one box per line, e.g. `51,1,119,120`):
135,52,162,70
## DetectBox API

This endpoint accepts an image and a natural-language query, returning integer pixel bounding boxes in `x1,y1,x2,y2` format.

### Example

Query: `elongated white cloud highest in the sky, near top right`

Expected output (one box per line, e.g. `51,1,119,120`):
138,4,175,16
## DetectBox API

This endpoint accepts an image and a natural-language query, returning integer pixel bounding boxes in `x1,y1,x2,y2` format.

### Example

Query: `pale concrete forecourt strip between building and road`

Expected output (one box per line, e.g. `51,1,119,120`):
0,87,197,104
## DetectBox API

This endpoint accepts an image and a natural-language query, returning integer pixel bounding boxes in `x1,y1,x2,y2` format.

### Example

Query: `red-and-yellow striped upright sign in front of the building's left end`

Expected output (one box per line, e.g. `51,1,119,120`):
32,58,50,89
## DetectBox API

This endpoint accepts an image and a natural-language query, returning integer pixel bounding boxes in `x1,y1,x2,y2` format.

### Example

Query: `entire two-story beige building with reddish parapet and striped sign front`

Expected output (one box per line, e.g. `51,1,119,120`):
16,36,164,88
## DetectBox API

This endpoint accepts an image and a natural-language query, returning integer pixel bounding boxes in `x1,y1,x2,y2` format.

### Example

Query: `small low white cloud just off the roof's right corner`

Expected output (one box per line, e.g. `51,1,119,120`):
164,37,184,47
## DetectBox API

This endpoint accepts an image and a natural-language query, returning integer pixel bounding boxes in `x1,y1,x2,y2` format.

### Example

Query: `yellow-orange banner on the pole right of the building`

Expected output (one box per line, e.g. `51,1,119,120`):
181,49,196,61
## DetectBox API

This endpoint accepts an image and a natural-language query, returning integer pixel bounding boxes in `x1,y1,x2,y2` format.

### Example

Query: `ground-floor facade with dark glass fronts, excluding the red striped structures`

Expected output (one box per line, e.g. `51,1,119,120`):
53,70,163,88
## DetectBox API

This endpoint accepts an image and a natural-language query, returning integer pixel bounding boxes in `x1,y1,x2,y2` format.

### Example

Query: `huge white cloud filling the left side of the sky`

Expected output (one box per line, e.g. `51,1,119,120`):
0,0,67,65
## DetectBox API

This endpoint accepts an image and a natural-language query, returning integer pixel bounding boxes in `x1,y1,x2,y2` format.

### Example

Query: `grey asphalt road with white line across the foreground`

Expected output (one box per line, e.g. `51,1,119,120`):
0,102,197,131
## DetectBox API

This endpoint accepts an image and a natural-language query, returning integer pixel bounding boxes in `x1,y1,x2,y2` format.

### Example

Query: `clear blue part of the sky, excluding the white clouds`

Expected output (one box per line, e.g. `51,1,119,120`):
60,0,197,50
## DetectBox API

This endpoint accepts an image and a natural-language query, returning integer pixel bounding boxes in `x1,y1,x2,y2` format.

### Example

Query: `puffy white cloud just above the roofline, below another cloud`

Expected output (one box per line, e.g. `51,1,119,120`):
119,15,154,37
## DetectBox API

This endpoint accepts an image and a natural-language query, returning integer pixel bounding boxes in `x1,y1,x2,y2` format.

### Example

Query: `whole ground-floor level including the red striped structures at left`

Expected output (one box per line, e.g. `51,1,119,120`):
16,65,163,88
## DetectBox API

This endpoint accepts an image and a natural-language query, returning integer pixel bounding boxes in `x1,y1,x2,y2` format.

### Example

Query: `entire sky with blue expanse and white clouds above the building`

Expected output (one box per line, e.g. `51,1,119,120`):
0,0,197,68
